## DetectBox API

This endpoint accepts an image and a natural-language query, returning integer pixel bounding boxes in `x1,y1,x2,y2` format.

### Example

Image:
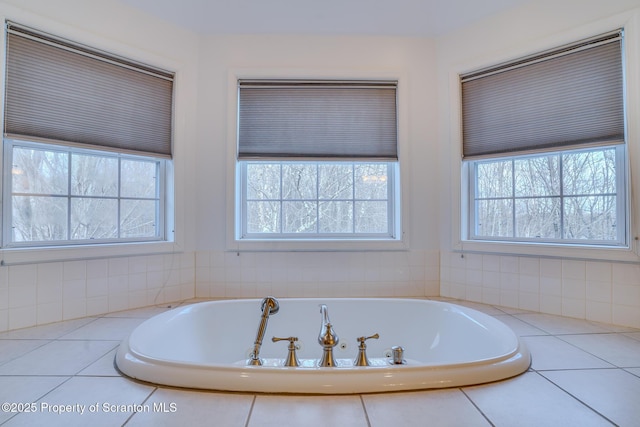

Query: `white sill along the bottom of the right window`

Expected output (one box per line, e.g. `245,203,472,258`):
453,240,640,263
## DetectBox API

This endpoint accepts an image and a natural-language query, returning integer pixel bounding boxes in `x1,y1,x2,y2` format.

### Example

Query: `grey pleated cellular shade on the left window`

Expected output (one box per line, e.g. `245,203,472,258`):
5,24,173,157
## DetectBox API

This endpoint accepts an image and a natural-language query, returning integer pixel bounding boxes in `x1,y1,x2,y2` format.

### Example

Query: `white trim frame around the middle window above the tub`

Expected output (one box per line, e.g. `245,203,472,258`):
226,69,410,252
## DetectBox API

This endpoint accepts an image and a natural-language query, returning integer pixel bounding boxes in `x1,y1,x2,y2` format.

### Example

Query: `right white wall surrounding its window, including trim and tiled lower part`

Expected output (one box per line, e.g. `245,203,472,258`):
437,0,640,327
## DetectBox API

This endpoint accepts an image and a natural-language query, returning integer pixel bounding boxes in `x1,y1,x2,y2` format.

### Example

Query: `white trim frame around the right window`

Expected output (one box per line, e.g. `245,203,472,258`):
449,12,640,263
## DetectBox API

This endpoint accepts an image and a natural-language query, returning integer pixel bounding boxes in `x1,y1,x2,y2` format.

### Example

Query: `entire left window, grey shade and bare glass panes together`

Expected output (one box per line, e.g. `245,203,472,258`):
2,22,173,247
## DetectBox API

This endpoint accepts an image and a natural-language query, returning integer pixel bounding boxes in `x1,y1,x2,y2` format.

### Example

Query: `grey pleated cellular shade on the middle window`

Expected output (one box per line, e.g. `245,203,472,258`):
238,81,398,160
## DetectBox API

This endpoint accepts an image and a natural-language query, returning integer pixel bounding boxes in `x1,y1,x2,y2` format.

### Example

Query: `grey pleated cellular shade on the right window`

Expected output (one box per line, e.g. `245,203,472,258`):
461,31,624,158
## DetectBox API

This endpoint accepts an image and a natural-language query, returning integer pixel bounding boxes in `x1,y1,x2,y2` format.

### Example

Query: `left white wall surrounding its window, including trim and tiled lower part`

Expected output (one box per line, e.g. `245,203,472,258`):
0,0,198,331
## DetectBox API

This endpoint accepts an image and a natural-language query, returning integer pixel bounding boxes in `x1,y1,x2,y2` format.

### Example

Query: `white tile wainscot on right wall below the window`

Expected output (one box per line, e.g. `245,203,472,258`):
440,253,640,328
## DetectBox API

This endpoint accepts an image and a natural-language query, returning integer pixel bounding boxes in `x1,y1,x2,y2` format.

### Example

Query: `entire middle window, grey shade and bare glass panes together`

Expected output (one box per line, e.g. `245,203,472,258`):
236,80,399,240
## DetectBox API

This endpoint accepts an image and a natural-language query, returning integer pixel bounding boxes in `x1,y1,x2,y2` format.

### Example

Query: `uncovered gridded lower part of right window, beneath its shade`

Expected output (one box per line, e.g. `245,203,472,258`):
468,145,627,246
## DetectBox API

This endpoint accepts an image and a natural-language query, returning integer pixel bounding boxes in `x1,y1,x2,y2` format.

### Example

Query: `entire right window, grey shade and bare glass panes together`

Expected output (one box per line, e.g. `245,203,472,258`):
461,31,628,247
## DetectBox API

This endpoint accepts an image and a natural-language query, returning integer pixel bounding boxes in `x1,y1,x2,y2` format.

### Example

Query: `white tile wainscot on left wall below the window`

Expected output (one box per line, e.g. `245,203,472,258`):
0,253,195,331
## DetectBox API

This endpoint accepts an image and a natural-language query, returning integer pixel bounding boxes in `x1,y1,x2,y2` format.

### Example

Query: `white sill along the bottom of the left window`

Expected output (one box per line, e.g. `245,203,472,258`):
0,242,182,266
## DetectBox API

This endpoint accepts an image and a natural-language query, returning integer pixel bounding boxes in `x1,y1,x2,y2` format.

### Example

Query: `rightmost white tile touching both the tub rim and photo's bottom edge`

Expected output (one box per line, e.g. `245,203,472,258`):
463,372,611,427
